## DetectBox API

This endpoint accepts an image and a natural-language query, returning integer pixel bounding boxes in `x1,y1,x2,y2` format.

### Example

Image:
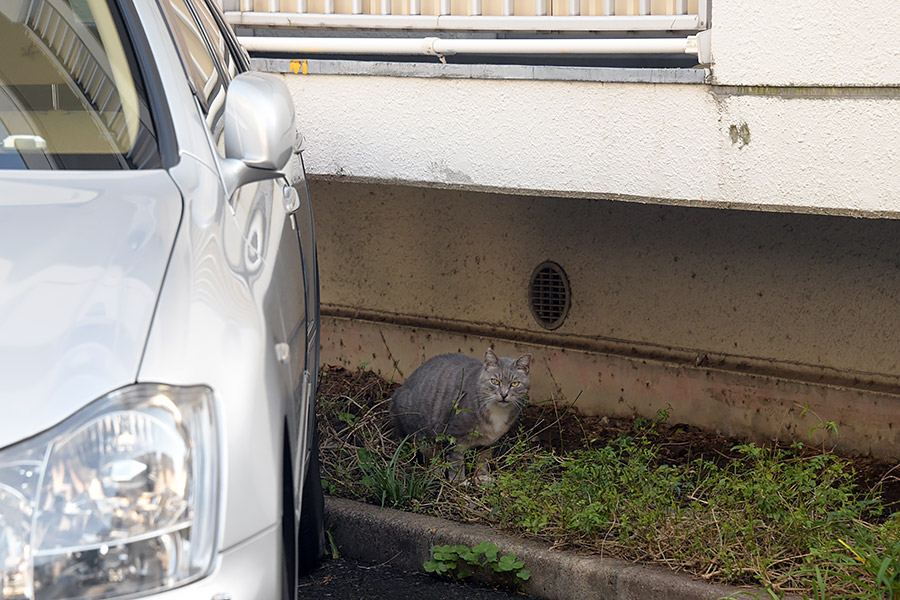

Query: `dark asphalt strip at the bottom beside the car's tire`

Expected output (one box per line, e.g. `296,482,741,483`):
298,558,528,600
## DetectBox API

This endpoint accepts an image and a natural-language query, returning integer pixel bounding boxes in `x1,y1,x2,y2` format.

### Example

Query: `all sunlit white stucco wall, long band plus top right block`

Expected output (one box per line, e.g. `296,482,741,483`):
274,0,900,217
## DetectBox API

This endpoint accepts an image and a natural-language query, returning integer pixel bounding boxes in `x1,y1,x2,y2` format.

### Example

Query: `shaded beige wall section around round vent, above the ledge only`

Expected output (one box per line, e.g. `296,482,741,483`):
313,182,900,377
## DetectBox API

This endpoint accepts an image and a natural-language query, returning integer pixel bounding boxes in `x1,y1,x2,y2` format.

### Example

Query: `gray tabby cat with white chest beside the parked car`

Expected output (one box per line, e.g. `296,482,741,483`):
390,348,532,480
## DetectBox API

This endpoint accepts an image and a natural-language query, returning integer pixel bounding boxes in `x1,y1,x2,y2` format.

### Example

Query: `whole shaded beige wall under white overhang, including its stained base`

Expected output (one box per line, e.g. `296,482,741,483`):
312,181,900,455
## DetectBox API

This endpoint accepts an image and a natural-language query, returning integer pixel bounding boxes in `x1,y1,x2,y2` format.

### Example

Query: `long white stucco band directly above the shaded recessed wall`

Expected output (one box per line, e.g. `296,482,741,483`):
285,74,900,216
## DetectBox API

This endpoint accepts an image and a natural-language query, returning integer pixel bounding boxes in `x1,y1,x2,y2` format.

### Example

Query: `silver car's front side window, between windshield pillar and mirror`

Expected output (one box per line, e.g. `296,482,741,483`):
160,0,227,148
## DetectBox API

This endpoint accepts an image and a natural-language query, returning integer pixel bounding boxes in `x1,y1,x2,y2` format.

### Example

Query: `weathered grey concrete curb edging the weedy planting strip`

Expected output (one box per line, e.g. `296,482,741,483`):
325,497,768,600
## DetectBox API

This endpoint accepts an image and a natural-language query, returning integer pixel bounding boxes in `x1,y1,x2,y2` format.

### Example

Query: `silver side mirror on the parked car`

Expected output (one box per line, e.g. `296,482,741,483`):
223,71,297,194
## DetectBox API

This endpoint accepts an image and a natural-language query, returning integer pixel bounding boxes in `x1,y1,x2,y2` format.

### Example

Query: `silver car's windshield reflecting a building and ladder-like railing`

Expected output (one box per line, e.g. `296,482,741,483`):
0,0,161,170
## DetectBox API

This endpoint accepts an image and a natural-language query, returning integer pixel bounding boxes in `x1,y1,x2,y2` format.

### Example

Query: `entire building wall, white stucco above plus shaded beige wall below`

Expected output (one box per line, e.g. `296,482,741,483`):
268,0,900,456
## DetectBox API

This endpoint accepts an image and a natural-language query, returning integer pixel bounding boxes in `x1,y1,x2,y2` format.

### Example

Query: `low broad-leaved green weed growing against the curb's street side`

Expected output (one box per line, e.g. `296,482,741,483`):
422,541,531,589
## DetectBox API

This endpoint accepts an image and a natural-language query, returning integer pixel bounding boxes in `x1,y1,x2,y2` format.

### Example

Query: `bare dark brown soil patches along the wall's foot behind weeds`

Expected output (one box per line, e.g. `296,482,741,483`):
319,366,900,513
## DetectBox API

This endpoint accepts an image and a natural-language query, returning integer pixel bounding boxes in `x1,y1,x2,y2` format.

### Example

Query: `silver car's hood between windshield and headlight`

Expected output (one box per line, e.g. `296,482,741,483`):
0,171,182,448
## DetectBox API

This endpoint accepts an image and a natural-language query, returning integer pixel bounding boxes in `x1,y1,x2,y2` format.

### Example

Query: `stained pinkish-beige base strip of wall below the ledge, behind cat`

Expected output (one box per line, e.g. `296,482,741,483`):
321,315,900,460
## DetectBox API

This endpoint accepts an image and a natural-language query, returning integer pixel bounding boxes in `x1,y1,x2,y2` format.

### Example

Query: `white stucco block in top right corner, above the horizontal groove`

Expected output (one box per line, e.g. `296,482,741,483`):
711,0,900,86
